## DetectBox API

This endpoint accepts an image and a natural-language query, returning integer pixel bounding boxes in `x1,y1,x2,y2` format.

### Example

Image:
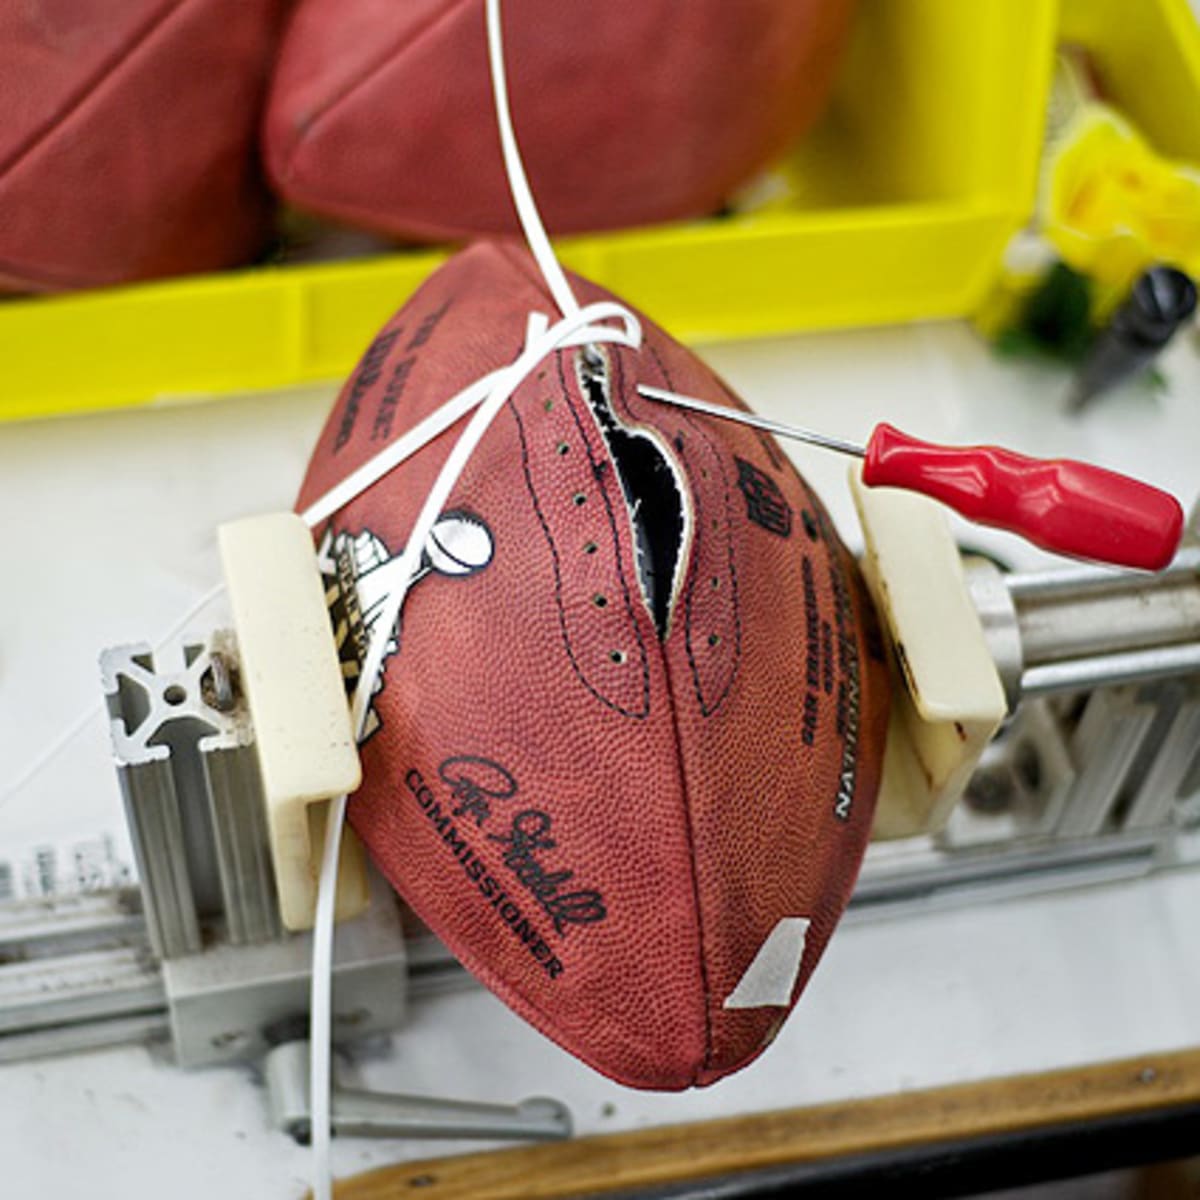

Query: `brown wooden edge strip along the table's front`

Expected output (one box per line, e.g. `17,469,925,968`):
336,1050,1200,1200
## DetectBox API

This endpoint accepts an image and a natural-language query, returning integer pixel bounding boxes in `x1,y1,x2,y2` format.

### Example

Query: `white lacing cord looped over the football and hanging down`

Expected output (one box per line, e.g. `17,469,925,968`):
302,0,642,1200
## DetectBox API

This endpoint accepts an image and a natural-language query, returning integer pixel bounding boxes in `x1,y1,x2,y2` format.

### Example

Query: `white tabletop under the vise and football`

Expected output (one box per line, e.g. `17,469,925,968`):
0,314,1200,1200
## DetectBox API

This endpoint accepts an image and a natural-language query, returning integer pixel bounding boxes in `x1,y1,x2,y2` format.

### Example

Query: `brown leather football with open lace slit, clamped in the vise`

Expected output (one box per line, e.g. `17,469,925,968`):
298,242,888,1088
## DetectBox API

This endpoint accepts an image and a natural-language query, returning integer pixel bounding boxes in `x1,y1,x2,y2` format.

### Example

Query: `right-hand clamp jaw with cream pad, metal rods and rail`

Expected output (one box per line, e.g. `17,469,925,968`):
852,478,1200,911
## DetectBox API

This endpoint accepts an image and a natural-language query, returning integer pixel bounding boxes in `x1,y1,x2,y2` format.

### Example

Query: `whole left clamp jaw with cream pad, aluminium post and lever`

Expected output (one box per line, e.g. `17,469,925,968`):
93,514,571,1140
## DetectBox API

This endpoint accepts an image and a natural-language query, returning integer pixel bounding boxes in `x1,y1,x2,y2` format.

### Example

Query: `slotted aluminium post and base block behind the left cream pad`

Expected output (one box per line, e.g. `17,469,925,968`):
101,551,406,1066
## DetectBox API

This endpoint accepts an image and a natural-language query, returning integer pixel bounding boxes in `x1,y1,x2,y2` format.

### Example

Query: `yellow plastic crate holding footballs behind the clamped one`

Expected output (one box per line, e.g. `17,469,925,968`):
0,0,1056,418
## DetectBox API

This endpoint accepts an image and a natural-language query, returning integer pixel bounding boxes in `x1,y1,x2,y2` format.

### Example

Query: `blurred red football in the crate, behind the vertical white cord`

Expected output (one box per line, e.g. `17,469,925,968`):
264,0,852,240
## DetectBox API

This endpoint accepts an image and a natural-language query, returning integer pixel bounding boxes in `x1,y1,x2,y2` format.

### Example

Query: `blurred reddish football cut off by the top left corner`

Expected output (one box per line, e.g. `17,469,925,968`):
0,0,284,292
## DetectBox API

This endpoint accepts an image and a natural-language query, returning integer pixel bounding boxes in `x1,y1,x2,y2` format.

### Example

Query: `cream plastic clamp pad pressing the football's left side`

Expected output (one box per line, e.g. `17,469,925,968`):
217,512,367,930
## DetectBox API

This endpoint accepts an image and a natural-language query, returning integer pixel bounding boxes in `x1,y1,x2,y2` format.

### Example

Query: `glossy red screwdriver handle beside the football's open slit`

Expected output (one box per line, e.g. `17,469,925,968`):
863,425,1183,571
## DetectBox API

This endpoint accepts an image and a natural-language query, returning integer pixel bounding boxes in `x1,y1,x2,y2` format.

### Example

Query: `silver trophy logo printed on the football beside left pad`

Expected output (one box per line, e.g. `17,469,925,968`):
317,510,494,742
